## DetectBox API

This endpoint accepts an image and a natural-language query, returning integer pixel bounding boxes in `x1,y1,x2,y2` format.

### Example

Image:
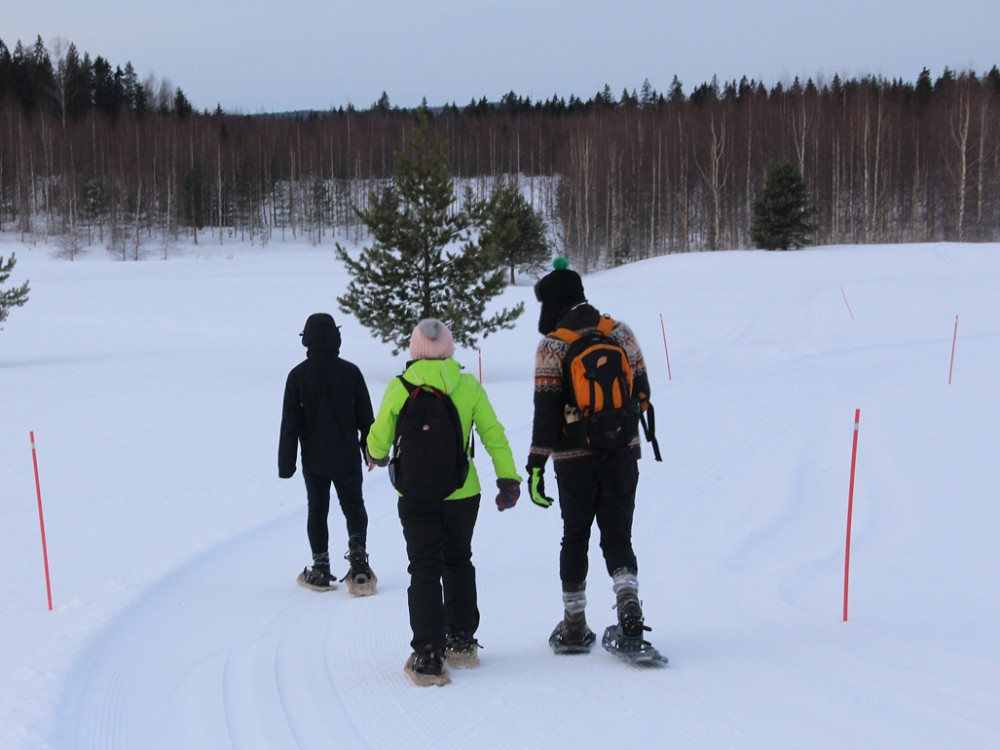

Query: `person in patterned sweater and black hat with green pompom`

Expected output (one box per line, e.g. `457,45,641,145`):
527,258,649,653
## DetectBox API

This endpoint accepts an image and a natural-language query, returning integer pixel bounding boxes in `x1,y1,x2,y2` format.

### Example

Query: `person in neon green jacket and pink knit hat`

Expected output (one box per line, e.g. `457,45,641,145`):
367,318,521,684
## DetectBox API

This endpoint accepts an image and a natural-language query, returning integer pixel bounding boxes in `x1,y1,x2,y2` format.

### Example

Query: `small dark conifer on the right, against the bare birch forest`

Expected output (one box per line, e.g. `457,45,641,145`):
750,162,816,250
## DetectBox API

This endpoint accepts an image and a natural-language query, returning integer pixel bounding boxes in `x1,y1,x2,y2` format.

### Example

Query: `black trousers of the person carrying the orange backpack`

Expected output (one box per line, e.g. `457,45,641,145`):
555,457,639,590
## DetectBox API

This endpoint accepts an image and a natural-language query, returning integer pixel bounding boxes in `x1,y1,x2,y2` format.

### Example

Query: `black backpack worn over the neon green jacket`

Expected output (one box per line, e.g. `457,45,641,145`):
389,376,469,499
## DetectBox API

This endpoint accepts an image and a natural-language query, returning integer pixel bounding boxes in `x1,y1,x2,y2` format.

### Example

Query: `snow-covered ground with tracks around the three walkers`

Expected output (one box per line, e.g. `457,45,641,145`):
0,239,1000,750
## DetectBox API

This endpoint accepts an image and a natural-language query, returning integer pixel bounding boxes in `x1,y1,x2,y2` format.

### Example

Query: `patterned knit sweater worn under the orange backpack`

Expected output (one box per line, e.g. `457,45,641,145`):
528,303,649,467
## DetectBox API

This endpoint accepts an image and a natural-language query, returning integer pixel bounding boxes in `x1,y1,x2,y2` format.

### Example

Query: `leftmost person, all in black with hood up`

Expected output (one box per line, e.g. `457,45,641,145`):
278,313,374,587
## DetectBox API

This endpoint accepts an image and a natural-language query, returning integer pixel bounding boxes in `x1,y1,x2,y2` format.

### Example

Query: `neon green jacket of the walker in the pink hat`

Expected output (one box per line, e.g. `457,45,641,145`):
368,358,521,500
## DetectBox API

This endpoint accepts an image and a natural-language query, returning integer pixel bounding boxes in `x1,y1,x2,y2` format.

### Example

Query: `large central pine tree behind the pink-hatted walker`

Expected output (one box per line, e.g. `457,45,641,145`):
336,117,524,354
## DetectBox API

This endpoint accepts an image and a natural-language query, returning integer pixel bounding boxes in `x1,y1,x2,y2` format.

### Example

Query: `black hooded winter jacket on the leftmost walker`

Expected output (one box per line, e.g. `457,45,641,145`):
278,313,374,478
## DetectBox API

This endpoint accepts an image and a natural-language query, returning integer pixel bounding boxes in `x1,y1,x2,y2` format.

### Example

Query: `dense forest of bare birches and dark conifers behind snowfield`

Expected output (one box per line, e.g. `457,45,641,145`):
0,40,1000,270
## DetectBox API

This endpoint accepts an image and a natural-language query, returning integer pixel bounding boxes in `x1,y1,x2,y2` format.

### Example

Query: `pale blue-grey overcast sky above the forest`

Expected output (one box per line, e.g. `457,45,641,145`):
7,0,1000,114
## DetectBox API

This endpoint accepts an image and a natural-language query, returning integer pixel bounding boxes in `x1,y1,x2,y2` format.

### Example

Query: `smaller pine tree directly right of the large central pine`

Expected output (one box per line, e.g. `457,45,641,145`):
479,181,552,284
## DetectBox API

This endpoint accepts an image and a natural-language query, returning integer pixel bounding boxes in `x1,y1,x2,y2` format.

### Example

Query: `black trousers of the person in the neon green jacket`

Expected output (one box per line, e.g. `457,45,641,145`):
398,495,480,651
